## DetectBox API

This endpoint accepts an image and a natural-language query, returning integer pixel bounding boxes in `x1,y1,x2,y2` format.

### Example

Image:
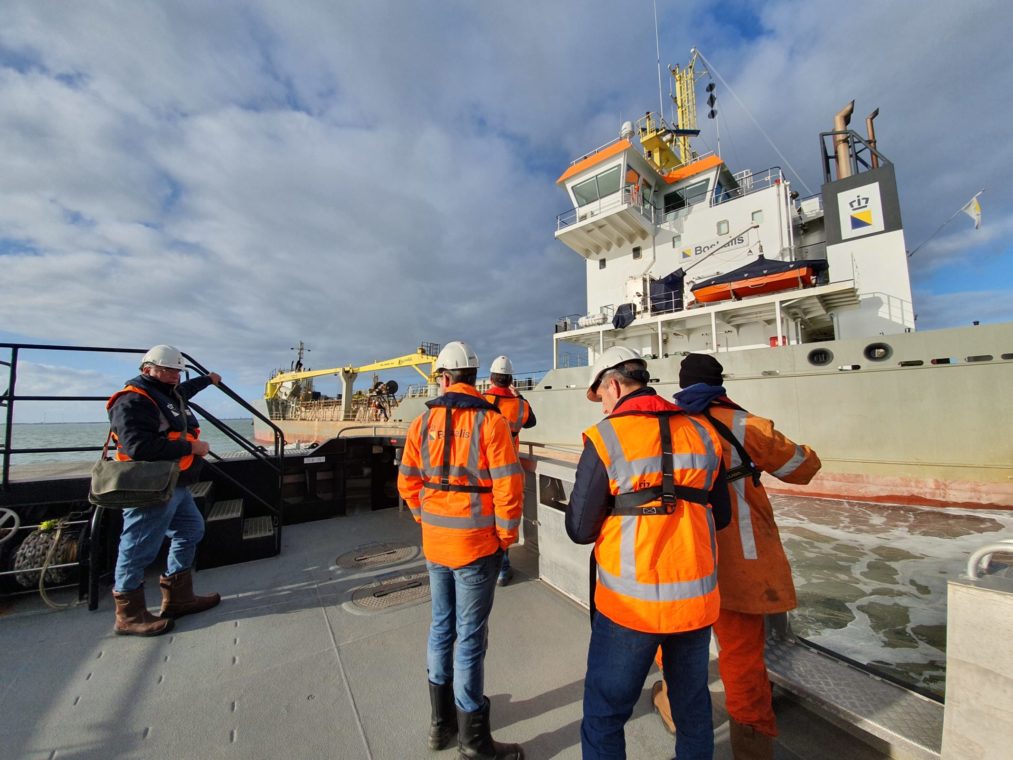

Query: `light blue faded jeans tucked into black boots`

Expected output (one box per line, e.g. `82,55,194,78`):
425,551,502,712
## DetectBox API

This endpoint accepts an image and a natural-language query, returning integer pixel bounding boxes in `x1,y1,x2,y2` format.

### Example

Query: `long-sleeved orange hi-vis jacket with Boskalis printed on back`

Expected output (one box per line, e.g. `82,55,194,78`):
397,383,524,567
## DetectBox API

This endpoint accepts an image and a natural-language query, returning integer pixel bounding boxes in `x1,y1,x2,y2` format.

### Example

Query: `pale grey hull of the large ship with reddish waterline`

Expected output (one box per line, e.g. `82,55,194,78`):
259,323,1013,509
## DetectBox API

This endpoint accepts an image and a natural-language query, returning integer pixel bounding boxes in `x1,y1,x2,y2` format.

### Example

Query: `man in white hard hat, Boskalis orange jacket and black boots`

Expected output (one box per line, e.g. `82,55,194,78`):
397,340,524,760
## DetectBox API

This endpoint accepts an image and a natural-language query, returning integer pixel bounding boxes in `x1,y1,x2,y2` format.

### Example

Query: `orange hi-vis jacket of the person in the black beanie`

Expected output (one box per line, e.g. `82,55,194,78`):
707,398,821,615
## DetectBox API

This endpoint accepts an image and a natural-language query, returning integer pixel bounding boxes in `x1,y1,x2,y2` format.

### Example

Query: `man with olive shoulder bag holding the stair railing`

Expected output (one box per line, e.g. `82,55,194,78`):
105,346,222,636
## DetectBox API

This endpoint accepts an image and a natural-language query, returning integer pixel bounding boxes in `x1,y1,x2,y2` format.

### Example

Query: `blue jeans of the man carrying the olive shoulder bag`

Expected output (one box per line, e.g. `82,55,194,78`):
112,486,204,592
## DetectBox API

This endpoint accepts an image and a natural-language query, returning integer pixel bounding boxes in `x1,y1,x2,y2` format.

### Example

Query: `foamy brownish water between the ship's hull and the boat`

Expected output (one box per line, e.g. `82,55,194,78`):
771,497,1013,696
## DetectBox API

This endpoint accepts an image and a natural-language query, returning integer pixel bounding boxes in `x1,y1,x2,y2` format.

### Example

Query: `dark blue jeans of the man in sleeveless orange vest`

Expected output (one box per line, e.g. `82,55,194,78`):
580,612,714,760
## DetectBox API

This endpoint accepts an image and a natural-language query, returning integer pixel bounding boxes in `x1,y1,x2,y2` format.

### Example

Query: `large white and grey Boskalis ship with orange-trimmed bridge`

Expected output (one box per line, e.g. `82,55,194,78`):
257,51,1013,508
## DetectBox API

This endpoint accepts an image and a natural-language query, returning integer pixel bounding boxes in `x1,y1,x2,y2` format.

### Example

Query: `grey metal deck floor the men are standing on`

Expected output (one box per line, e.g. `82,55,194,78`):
0,510,899,760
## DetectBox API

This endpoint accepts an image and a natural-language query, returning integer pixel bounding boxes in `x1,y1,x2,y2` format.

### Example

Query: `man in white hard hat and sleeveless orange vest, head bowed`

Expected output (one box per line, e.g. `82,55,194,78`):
565,346,730,760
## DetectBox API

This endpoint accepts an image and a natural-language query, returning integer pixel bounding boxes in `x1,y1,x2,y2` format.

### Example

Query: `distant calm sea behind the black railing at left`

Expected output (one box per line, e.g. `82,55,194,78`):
0,419,253,465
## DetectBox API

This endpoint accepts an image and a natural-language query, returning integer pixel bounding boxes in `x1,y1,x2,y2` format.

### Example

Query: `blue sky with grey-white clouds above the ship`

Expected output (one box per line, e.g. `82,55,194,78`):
0,0,1013,422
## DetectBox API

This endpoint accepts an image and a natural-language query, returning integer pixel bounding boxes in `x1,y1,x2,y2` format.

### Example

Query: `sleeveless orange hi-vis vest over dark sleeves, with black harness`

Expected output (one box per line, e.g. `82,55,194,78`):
583,396,721,633
